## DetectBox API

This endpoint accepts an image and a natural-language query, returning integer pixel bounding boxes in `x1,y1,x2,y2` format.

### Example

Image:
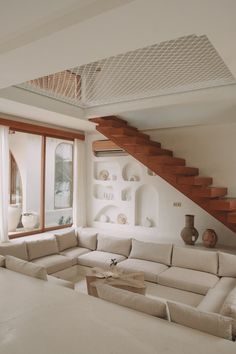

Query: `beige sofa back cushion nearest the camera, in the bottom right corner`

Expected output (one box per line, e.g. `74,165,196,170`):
167,301,233,340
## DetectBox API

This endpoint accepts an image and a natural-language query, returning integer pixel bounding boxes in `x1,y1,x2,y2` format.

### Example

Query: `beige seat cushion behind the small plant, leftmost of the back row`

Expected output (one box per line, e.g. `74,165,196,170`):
78,251,126,267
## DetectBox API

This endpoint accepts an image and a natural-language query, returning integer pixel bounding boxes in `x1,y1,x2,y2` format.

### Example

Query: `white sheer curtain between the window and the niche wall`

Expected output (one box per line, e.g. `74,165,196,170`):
73,139,86,227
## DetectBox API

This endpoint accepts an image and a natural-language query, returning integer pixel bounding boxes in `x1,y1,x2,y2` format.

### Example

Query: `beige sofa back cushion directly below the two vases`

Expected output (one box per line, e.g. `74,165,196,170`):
172,246,218,274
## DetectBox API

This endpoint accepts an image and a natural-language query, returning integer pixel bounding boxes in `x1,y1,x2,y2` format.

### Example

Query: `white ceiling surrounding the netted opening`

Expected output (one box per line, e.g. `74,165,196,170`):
0,0,236,130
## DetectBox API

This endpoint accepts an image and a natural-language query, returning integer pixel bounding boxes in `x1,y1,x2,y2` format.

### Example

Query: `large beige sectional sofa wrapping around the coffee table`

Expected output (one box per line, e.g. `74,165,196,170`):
0,229,236,335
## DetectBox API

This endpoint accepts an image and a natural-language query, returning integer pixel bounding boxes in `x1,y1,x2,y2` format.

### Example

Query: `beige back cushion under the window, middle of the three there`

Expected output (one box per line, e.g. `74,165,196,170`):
27,237,59,260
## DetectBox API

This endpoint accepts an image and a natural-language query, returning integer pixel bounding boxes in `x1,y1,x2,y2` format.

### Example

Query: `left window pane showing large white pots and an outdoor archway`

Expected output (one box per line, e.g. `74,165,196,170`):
8,132,42,235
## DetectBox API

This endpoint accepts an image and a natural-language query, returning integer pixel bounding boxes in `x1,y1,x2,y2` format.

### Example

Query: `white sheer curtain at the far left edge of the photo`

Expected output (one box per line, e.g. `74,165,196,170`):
0,125,9,242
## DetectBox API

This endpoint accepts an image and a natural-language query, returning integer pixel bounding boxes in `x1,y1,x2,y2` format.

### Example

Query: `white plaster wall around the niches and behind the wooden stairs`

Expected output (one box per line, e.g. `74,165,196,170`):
87,123,236,246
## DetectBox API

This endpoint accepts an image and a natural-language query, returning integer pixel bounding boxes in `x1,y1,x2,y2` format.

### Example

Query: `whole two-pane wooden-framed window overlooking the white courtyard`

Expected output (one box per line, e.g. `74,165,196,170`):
8,131,73,238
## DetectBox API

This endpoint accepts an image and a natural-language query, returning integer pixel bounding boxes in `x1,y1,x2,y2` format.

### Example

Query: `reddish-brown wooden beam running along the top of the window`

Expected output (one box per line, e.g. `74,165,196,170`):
0,117,85,140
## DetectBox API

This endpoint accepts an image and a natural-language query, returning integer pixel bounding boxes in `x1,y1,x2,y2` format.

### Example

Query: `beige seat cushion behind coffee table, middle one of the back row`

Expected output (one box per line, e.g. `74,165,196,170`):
117,258,168,283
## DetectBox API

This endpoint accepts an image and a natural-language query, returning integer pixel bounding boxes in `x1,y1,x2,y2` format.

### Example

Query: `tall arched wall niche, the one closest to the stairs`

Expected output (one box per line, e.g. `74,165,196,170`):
135,184,159,227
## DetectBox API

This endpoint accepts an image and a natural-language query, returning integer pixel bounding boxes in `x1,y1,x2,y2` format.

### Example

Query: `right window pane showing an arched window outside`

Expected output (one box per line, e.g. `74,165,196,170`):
45,138,73,227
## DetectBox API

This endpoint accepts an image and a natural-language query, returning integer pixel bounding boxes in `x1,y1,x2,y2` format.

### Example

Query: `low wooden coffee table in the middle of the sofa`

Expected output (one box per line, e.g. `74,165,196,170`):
86,268,146,297
